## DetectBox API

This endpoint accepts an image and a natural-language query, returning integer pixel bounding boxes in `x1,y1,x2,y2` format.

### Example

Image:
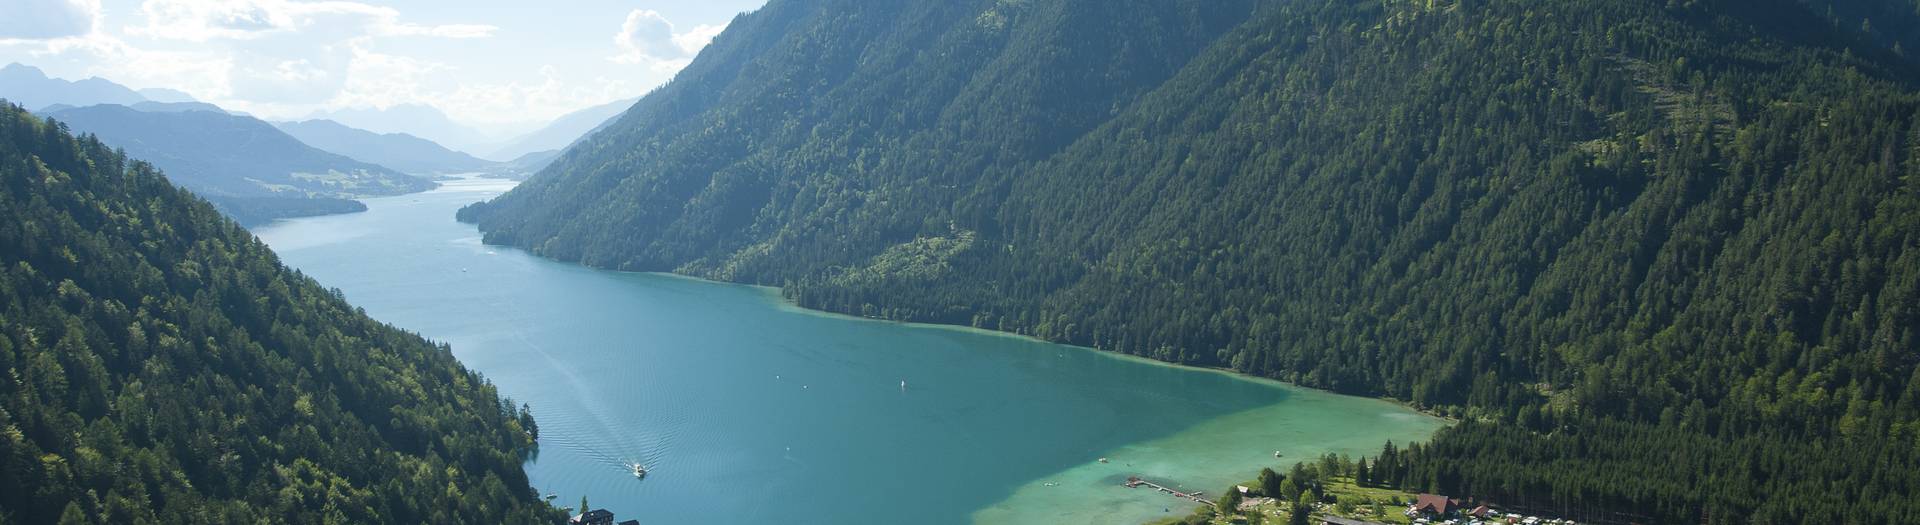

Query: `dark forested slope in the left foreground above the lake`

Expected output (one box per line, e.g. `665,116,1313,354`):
0,104,557,523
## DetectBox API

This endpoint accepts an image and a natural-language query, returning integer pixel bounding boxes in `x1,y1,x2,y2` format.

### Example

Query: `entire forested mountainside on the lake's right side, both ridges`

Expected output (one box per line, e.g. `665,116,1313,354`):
463,0,1920,523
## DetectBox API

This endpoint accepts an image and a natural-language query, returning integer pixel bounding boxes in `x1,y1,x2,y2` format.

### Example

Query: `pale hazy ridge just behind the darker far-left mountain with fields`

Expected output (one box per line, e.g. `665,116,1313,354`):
275,119,499,175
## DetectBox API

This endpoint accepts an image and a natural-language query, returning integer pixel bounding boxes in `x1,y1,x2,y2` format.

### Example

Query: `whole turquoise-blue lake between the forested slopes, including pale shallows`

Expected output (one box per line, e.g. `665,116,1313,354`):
255,179,1444,523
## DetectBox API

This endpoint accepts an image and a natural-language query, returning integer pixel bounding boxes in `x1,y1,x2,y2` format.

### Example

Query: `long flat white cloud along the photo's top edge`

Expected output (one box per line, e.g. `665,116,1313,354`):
127,0,495,42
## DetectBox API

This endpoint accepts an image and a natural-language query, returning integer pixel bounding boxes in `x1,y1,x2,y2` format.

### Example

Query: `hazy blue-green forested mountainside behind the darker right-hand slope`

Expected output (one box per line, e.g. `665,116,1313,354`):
467,0,1252,267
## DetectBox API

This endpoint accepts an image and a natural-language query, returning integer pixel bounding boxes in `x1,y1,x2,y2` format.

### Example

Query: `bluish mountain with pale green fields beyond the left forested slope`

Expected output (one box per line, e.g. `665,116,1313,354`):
46,104,434,223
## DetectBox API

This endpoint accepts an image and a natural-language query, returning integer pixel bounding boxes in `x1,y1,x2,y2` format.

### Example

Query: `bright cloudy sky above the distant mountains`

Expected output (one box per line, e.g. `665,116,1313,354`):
0,0,764,133
